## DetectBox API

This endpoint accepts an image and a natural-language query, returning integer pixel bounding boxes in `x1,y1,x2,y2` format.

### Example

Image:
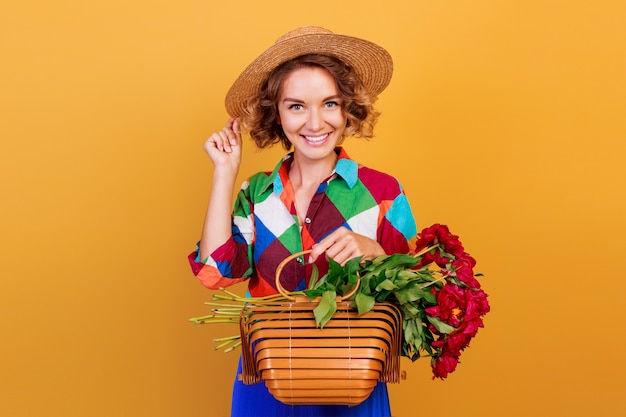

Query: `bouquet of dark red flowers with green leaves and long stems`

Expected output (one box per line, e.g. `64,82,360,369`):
191,224,489,379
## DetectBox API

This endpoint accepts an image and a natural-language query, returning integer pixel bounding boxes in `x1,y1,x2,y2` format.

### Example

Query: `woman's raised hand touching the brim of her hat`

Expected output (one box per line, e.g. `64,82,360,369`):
204,118,241,174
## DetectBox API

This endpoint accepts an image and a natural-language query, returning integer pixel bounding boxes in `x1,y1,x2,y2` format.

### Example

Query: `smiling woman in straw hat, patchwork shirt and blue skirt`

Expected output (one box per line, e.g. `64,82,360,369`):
189,27,416,417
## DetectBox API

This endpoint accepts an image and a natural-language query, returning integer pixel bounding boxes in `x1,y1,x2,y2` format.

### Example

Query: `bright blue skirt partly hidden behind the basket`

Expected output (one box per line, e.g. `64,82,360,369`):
230,358,391,417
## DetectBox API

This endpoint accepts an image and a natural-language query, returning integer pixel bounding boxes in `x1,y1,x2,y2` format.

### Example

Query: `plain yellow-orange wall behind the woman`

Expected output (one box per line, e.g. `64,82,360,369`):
0,0,626,417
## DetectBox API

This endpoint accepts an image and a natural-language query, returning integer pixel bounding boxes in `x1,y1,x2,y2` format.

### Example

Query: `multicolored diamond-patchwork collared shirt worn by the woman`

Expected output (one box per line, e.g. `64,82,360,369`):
189,147,416,297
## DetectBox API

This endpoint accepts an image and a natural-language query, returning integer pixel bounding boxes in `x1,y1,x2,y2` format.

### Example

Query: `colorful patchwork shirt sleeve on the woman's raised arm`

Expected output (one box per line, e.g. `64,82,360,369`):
188,182,255,289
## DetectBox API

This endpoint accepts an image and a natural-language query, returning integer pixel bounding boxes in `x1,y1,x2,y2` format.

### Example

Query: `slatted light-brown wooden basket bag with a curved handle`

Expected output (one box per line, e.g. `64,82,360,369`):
240,251,402,405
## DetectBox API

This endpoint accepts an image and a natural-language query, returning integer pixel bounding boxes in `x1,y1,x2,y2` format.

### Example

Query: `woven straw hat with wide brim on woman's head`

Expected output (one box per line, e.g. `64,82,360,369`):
226,26,393,117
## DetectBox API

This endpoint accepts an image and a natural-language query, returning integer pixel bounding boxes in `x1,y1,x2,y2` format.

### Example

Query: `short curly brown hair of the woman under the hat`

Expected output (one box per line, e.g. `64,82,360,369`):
241,54,380,150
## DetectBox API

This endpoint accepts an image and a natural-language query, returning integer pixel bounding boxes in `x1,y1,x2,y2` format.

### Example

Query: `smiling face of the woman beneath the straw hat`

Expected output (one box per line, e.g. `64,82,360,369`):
278,67,347,160
